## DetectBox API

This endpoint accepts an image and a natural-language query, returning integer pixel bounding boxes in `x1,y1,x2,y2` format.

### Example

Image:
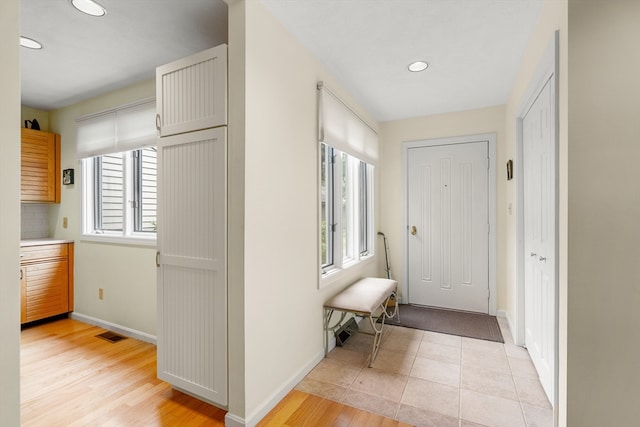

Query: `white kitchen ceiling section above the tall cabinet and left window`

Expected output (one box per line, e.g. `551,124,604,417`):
21,0,227,110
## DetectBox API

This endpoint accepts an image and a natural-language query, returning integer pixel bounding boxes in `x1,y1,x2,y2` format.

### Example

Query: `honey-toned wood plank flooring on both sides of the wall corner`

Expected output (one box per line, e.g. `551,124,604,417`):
25,319,407,427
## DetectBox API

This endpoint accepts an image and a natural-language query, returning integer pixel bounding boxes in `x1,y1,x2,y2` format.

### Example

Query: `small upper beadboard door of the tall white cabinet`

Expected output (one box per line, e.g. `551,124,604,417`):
156,44,227,137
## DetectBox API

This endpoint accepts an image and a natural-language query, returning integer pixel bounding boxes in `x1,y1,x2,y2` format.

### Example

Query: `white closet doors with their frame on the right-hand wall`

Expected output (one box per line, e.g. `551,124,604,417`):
514,33,558,408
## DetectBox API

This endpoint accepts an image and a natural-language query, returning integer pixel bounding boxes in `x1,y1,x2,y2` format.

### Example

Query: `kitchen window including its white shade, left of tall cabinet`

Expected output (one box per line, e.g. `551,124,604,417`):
76,100,157,244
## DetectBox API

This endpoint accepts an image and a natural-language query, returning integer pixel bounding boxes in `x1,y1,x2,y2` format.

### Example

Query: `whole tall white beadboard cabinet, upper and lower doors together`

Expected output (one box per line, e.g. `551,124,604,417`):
156,45,228,406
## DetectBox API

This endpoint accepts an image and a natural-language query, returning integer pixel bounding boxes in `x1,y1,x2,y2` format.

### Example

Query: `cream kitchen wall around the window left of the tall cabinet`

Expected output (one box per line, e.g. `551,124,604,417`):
49,79,156,336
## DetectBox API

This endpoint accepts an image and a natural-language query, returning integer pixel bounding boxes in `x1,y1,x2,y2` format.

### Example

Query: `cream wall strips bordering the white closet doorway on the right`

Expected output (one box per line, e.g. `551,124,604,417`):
498,0,568,425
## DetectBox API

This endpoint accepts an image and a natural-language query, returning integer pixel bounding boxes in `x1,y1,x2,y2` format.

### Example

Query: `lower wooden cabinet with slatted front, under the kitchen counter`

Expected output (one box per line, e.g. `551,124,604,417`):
20,243,73,323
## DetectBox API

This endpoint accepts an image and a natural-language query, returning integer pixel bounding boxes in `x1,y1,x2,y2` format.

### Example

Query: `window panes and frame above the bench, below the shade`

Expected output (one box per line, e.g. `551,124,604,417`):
320,143,373,274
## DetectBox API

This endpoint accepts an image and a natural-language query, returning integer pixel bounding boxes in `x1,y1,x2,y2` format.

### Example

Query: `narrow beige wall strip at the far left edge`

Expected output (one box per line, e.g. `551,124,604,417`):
0,0,20,427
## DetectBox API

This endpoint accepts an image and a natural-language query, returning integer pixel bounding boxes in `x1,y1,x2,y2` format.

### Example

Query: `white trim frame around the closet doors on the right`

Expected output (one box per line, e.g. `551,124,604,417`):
509,31,560,408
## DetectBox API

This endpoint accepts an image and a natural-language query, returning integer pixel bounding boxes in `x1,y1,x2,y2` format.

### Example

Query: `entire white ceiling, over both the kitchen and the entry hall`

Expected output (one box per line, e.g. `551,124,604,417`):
21,0,542,121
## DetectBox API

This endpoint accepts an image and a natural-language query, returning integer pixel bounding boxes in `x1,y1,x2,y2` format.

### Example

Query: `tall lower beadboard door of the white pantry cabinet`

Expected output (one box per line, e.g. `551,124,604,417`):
157,127,227,406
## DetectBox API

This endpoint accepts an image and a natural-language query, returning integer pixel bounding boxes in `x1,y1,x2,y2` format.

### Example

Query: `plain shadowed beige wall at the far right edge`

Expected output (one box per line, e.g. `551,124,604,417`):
567,0,640,427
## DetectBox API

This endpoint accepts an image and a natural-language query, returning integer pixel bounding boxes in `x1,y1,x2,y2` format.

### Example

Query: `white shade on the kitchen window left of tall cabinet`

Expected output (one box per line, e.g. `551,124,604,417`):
76,99,157,159
